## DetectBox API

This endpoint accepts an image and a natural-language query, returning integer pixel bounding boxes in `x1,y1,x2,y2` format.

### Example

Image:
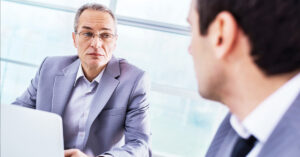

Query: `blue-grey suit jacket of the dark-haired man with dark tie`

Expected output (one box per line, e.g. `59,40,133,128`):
206,94,300,157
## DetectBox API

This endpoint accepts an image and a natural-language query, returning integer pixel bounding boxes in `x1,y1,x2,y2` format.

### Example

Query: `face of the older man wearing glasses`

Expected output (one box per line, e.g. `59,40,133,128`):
73,9,117,69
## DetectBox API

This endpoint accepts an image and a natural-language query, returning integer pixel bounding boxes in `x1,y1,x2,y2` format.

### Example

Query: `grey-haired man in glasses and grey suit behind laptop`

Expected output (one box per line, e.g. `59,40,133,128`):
14,4,151,157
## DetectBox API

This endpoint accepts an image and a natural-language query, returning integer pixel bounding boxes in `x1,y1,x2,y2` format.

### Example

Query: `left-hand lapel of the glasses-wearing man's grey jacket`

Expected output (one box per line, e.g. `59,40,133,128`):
51,59,80,115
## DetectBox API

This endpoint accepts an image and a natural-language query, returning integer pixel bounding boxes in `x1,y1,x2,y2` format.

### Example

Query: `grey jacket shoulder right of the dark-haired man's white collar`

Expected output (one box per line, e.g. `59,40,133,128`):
259,94,300,157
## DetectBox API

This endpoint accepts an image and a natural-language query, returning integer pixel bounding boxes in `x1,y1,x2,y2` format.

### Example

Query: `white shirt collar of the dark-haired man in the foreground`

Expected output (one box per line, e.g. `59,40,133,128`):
230,73,300,143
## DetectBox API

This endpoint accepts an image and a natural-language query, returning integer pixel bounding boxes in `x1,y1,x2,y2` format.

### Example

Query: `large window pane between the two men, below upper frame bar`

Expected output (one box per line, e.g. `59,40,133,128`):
115,25,197,91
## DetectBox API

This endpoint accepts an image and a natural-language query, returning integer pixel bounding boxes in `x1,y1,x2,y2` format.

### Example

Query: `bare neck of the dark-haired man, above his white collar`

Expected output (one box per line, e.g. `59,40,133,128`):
222,72,298,121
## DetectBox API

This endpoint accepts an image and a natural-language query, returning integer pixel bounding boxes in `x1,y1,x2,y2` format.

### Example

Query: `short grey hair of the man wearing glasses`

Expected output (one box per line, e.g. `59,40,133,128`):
74,3,117,33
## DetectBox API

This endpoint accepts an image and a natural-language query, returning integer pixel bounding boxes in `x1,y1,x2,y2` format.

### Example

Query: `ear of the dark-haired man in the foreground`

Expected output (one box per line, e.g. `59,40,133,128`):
208,11,238,59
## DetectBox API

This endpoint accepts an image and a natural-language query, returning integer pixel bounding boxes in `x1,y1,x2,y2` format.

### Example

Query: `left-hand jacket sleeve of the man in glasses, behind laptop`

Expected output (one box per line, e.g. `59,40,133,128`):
12,59,46,109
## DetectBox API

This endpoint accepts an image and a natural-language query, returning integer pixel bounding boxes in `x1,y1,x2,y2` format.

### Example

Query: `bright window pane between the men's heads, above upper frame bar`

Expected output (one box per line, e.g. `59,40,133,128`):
116,0,191,26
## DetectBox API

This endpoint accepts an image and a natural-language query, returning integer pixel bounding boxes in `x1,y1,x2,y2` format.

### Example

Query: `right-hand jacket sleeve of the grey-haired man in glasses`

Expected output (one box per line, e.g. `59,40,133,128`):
100,72,152,157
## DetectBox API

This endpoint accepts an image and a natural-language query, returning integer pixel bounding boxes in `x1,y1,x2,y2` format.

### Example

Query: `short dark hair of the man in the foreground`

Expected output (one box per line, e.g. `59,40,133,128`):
197,0,300,75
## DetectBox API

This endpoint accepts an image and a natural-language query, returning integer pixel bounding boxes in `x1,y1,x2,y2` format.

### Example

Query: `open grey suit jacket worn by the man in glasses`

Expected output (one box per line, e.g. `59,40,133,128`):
13,56,151,157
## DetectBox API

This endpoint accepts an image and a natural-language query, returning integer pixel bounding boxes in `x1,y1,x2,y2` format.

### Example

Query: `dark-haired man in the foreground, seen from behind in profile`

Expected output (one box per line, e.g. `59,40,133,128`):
188,0,300,157
